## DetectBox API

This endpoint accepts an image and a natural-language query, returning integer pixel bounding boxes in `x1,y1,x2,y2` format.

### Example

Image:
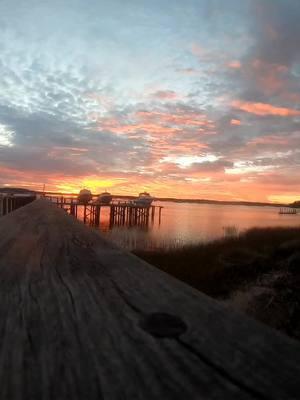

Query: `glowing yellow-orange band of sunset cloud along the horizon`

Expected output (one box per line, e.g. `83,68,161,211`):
0,164,299,202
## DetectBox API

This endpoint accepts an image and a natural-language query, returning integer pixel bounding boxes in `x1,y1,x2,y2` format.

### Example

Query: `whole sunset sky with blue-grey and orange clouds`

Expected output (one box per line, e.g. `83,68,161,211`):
0,0,300,202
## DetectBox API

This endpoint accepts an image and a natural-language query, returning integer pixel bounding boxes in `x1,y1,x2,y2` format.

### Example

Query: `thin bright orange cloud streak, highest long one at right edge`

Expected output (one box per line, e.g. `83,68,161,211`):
231,100,300,117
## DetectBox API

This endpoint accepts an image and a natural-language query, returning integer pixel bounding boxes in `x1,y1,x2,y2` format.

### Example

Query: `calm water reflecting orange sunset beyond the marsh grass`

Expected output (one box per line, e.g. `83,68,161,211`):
88,202,300,250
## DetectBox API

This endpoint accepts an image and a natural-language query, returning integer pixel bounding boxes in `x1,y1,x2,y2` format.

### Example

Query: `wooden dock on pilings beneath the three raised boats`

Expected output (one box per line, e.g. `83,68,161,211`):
45,195,163,227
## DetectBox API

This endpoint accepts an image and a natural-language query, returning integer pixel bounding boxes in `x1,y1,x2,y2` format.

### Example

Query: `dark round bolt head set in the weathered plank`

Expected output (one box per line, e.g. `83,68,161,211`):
140,313,187,338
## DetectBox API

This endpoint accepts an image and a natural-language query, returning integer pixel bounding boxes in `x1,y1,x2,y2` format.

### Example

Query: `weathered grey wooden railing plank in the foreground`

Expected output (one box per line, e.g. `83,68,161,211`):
0,200,300,400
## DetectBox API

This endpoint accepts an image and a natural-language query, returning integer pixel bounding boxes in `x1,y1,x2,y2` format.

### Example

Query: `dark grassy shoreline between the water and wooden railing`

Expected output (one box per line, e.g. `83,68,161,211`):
134,227,300,340
